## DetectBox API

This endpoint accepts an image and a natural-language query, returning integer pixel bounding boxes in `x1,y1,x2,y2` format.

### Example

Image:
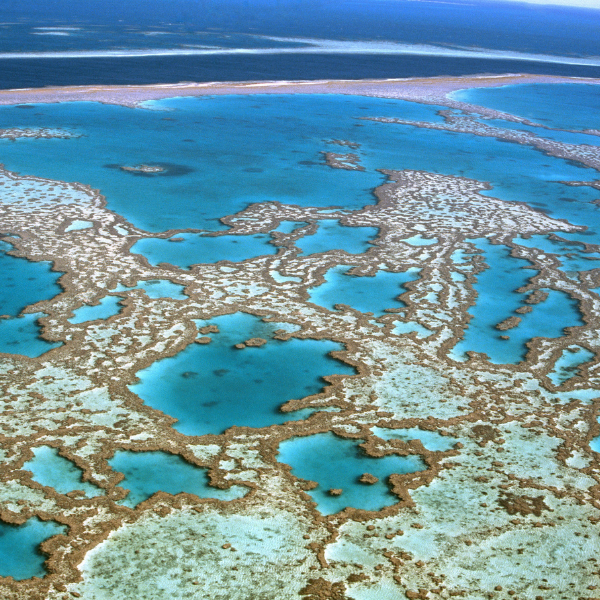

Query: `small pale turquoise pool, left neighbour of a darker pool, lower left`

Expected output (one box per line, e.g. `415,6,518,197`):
21,446,104,498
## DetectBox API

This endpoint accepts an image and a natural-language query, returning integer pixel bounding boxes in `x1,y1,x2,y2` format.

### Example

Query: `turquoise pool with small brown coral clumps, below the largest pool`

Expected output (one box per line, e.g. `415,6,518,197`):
278,432,427,515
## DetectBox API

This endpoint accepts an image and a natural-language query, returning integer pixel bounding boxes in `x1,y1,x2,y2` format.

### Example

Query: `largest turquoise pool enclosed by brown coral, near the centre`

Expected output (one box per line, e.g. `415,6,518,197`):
130,313,355,435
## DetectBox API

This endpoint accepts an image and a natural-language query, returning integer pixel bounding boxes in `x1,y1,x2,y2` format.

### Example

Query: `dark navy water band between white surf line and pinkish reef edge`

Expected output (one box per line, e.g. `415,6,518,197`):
0,54,600,89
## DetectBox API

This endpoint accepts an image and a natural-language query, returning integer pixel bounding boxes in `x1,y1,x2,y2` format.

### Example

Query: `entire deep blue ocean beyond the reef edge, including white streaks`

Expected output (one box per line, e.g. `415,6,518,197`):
0,0,600,89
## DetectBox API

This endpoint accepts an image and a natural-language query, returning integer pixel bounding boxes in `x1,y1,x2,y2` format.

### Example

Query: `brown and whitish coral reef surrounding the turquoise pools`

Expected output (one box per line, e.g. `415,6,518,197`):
0,77,600,600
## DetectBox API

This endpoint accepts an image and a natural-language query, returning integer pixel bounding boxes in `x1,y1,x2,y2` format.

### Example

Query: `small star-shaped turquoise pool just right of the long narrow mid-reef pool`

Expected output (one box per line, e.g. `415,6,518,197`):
296,219,379,256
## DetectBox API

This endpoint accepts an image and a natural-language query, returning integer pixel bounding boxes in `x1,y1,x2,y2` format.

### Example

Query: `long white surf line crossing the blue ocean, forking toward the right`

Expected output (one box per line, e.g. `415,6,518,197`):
0,36,600,67
